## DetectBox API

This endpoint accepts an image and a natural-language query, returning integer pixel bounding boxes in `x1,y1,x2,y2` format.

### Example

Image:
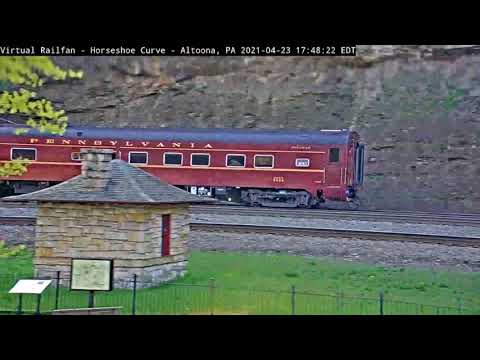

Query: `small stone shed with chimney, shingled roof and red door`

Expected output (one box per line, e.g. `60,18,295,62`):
4,149,214,288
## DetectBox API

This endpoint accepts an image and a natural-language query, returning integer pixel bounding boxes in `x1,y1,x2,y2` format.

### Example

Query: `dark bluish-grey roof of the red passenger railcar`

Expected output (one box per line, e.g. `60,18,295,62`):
0,126,352,145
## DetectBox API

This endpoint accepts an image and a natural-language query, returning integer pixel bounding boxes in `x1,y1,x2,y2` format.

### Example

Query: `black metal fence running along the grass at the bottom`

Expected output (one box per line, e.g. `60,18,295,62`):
0,272,480,315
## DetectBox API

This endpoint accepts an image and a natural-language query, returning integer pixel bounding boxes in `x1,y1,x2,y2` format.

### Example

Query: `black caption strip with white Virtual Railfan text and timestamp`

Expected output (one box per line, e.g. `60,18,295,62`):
0,40,356,56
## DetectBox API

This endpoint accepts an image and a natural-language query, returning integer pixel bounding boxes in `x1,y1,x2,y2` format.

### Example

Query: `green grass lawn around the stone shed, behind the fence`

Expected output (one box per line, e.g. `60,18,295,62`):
0,251,480,314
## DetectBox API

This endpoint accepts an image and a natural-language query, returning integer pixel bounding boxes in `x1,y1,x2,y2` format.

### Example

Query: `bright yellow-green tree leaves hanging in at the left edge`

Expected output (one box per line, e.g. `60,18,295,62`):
0,56,83,176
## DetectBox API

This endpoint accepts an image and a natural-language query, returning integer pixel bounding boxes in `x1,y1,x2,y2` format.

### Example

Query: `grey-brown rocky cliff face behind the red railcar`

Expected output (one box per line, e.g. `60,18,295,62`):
36,45,480,212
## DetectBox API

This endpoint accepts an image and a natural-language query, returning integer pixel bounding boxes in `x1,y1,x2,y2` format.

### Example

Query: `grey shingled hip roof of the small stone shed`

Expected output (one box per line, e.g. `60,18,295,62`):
3,150,216,204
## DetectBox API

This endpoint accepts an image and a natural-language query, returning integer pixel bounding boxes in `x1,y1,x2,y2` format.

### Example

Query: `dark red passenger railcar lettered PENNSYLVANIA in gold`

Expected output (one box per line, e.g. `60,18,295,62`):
0,126,363,207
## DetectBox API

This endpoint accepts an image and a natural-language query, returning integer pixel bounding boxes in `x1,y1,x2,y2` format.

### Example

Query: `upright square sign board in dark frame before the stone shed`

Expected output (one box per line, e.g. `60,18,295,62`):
70,259,113,291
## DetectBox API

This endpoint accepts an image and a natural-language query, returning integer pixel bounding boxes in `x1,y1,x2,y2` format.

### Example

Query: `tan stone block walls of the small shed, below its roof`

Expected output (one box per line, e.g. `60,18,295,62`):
34,203,190,287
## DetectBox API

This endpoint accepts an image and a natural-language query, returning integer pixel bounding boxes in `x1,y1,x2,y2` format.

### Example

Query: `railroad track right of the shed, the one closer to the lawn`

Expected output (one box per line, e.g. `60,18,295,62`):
190,222,480,248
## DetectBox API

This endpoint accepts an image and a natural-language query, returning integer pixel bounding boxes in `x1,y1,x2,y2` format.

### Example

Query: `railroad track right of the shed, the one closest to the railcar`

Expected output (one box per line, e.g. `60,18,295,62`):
191,205,480,227
